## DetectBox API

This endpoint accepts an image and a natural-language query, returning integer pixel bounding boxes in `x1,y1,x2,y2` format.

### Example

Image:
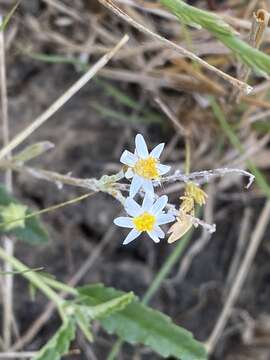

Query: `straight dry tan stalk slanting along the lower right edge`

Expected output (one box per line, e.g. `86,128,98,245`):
205,200,270,354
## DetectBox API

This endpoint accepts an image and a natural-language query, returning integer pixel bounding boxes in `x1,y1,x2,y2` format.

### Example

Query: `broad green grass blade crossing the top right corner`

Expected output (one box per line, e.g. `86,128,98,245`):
160,0,270,74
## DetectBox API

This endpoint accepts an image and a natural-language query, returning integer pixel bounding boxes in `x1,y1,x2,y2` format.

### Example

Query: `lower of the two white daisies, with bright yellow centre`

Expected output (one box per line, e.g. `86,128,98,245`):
114,194,175,245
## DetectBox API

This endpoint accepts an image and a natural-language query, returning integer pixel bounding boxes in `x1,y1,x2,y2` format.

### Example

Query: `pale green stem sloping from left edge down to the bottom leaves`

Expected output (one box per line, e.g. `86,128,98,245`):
0,247,64,316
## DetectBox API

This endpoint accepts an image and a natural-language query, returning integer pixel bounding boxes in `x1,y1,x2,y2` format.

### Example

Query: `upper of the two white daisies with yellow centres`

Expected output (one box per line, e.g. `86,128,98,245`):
120,134,171,197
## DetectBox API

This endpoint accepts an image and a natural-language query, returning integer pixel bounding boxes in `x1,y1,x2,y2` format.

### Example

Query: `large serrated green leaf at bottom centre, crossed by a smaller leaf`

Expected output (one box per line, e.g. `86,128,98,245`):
78,284,207,360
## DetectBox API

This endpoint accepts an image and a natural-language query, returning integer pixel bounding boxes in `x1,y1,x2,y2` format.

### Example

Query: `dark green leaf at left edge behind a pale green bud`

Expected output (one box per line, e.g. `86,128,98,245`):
0,185,48,245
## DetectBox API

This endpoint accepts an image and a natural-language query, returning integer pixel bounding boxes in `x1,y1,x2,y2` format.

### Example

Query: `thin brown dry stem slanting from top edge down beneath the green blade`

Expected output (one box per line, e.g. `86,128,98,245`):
98,0,252,93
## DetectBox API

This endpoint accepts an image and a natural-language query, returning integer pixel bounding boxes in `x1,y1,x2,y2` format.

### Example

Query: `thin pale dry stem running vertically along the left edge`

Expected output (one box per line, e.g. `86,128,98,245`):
0,15,14,349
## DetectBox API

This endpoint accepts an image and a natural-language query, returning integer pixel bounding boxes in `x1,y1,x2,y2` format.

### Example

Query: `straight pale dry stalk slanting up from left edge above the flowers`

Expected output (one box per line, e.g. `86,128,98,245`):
0,35,129,159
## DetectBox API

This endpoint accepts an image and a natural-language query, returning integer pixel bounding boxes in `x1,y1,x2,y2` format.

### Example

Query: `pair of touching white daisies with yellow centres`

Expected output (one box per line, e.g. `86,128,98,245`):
114,134,175,245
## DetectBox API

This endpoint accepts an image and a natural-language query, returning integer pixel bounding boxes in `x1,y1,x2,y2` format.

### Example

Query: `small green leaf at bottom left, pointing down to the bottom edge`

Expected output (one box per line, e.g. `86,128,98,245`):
33,318,76,360
